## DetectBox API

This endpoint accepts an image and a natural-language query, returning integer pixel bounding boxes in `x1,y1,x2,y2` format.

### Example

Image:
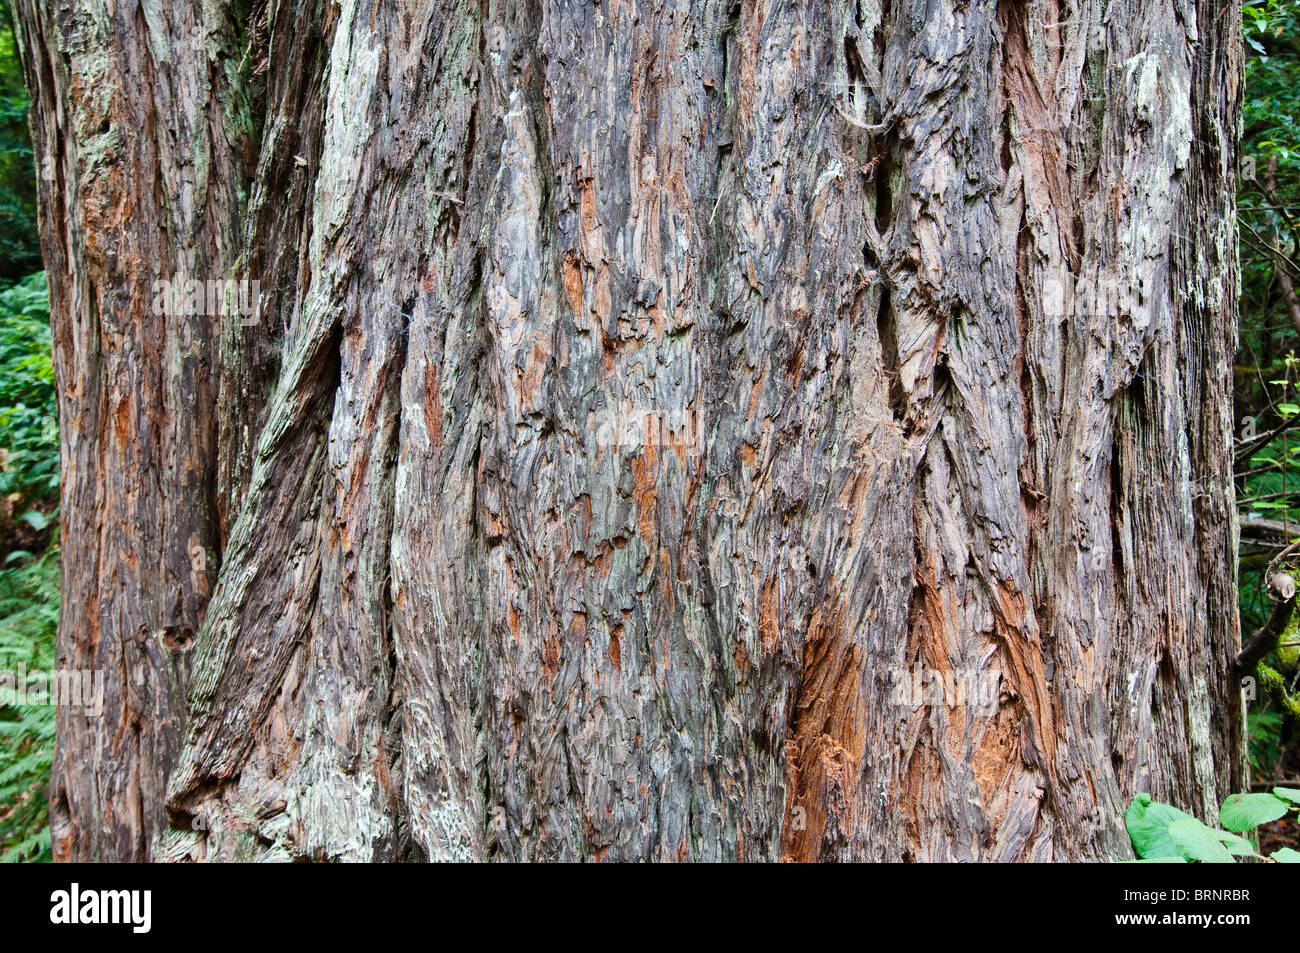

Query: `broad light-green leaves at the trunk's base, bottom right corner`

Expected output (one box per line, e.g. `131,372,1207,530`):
1125,788,1300,863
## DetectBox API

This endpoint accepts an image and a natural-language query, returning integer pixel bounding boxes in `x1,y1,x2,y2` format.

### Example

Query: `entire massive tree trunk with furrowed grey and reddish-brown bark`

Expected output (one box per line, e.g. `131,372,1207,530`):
18,0,1242,861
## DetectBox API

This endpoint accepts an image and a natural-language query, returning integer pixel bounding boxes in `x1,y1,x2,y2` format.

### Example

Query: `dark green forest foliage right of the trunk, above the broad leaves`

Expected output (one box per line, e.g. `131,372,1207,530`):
1234,0,1300,779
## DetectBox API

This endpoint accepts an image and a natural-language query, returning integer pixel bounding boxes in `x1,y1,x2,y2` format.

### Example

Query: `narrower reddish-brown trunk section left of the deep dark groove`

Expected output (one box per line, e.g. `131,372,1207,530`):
17,3,242,859
